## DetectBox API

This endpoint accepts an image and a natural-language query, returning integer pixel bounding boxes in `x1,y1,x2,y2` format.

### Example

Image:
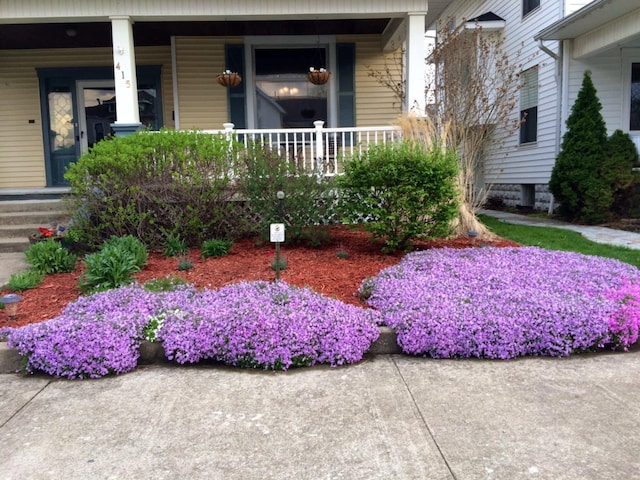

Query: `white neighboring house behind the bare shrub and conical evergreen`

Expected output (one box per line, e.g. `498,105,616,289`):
432,0,640,208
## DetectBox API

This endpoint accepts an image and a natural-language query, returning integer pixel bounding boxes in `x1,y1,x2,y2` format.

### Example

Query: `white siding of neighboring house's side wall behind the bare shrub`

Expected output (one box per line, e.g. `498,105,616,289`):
432,0,563,184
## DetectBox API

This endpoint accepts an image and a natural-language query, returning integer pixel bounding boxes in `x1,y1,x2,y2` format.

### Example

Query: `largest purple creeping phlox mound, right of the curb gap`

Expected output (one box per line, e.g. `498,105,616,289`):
363,247,640,359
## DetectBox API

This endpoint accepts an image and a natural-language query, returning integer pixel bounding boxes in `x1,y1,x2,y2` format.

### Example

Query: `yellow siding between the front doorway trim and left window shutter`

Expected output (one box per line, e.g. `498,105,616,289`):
175,37,228,130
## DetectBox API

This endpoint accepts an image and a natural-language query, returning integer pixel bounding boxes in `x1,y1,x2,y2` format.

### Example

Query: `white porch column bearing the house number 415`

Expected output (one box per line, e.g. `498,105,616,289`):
110,16,141,136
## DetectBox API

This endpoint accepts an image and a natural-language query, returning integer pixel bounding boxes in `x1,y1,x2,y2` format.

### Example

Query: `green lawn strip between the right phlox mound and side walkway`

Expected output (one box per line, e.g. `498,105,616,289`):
478,215,640,268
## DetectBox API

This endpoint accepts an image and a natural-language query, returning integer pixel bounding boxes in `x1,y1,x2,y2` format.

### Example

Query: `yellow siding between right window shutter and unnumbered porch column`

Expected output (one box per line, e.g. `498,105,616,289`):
337,35,402,127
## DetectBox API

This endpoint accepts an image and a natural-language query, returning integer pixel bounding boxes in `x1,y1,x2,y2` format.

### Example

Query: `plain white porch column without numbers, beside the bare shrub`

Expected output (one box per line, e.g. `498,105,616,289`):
404,12,427,114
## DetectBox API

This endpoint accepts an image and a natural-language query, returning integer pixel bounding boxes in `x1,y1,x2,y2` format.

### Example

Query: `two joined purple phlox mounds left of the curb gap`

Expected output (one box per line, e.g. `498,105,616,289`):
0,282,379,379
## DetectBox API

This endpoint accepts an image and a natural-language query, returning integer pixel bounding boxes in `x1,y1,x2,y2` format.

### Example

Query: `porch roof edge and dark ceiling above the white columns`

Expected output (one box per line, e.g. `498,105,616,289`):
0,0,452,49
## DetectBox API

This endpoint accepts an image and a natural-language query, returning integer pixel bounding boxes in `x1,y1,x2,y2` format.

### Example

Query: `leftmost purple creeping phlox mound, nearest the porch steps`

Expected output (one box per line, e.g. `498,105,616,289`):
0,285,195,379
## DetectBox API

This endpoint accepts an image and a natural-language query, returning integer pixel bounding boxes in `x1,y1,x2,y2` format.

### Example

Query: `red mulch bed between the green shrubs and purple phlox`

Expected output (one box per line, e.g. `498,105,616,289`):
0,226,518,328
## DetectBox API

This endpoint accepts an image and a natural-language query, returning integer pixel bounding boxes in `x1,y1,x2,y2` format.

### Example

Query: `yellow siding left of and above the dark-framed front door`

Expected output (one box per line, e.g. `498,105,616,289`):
0,47,173,188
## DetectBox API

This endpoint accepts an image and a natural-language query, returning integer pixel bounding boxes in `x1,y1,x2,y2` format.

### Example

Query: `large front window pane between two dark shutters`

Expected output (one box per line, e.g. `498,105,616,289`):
255,48,329,128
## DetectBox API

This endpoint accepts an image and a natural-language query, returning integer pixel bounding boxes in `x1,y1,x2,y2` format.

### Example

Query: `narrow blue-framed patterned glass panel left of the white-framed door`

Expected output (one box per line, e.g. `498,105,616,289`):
47,87,76,186
